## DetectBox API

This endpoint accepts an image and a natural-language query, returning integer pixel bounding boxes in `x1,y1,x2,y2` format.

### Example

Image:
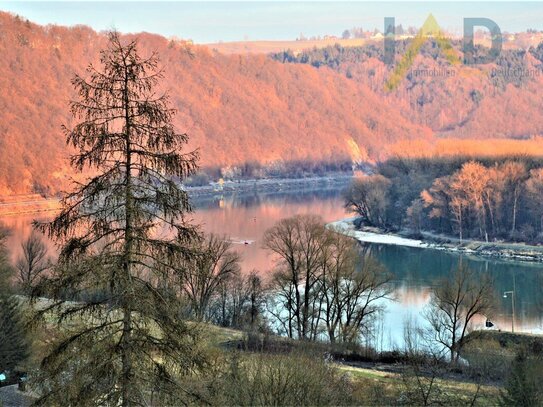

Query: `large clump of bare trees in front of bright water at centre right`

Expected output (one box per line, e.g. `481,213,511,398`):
264,215,390,342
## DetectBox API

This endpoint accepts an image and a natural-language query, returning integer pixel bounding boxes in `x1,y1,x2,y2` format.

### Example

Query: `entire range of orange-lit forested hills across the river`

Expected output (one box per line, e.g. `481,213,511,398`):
0,13,543,195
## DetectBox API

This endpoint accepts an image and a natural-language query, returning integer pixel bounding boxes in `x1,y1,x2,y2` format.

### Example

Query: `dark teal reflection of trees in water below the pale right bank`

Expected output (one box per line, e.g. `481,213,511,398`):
363,244,543,321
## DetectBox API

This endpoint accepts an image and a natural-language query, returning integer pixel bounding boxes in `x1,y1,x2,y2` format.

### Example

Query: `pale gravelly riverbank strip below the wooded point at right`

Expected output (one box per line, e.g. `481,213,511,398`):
328,218,543,263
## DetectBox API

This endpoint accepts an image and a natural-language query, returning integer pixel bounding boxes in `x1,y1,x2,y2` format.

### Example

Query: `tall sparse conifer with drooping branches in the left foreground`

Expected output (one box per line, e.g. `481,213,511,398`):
35,33,201,406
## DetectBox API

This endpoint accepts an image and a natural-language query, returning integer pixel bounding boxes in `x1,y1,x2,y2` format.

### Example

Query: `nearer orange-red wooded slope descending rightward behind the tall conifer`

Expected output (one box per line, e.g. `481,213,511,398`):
0,13,431,194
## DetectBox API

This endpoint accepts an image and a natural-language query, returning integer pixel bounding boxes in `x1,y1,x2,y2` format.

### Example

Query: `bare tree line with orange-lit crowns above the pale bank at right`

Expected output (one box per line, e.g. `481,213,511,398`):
344,157,543,243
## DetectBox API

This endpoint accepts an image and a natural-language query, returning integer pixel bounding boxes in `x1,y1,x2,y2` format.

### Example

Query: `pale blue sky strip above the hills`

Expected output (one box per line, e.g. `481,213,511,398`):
0,1,543,43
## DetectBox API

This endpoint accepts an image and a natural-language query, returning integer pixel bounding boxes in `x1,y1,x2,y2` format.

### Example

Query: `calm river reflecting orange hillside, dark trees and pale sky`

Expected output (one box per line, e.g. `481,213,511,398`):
1,185,543,349
